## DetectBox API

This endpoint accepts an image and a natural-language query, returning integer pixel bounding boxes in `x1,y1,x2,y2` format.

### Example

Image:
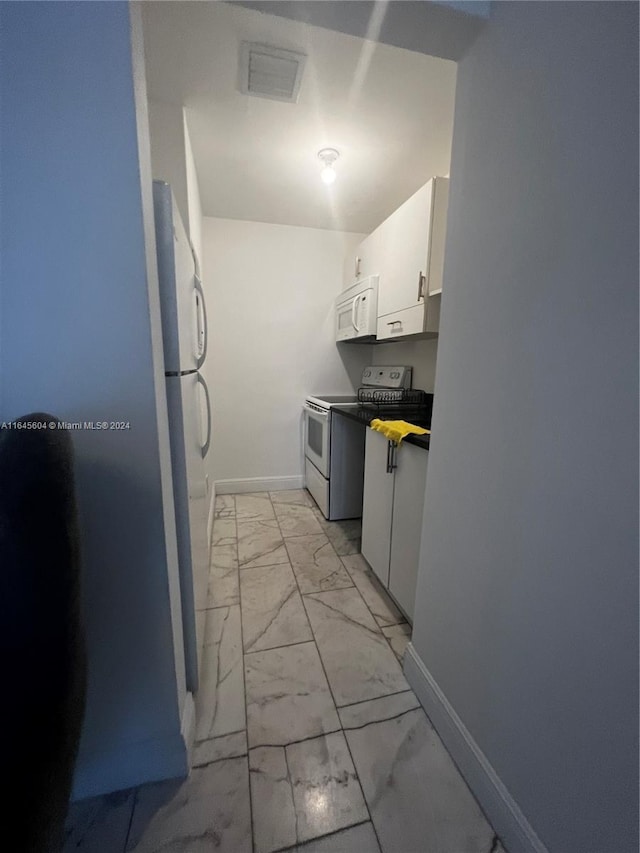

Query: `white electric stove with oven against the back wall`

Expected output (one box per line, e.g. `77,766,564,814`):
303,365,412,521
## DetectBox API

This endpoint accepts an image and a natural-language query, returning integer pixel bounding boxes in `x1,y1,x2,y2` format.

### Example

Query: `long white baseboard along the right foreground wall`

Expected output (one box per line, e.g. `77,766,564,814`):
404,643,548,853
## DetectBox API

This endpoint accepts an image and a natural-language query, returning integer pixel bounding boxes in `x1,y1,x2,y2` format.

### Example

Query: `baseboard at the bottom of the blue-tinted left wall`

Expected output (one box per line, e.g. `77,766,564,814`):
71,732,189,801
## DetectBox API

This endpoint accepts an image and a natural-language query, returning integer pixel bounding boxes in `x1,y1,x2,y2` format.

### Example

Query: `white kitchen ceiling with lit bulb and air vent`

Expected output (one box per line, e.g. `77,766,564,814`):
142,0,456,233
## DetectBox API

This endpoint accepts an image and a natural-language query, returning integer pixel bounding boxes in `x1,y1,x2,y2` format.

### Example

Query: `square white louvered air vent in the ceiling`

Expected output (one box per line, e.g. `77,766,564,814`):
240,42,307,103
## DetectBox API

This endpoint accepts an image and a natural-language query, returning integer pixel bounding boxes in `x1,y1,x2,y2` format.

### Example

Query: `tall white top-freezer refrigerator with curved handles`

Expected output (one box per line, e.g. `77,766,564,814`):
153,181,211,692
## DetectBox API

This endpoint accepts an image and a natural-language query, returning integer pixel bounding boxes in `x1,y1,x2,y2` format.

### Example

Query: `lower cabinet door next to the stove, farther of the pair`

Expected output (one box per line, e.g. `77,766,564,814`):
362,429,394,586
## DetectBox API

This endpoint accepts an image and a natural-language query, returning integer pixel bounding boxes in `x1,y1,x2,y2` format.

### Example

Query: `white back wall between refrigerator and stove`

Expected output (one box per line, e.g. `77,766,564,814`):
203,217,371,481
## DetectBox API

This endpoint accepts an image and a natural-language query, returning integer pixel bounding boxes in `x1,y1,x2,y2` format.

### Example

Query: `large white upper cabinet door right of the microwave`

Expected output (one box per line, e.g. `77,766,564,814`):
378,179,434,317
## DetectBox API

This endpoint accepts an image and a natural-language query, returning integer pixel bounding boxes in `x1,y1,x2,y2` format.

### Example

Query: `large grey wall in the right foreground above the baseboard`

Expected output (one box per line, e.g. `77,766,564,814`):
413,3,638,853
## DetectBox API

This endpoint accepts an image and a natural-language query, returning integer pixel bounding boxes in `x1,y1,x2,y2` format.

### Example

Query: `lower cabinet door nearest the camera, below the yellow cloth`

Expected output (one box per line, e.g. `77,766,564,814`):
389,443,429,622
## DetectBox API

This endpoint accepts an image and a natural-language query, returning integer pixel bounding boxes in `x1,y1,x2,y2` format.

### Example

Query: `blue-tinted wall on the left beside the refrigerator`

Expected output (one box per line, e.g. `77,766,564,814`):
0,3,187,796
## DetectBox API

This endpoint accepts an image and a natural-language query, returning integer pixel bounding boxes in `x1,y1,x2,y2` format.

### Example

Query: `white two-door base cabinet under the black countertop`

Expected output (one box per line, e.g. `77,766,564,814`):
362,429,429,622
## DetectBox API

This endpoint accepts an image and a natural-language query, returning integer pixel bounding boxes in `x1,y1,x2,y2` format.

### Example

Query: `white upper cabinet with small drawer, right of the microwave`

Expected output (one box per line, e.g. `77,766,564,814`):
376,178,449,339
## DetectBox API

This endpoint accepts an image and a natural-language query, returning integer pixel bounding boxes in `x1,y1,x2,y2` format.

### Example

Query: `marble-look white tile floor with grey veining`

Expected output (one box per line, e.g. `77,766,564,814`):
64,491,505,853
